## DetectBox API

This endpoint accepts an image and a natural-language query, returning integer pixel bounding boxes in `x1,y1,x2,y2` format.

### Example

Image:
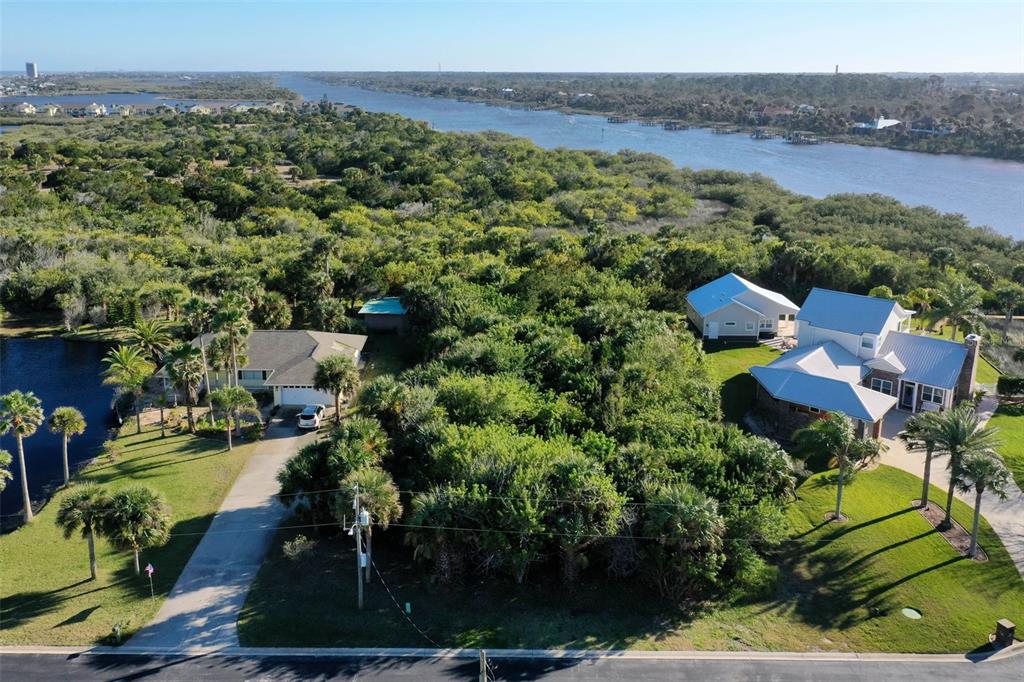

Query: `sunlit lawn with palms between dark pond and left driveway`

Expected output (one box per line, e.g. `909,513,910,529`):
0,426,255,644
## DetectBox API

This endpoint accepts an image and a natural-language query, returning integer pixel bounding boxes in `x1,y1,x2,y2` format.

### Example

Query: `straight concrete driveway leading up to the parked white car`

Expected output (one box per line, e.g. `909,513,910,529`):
130,419,315,648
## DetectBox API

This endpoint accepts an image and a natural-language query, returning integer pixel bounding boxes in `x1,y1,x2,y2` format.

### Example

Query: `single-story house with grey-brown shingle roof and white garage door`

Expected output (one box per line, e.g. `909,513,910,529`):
180,330,367,406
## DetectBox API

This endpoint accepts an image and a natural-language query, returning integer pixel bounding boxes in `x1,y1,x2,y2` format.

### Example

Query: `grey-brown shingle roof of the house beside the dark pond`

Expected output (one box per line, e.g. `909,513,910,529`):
193,330,367,386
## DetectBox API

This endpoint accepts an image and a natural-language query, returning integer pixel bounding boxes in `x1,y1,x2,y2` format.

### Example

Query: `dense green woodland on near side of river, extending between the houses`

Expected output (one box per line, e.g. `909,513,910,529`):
0,104,1024,600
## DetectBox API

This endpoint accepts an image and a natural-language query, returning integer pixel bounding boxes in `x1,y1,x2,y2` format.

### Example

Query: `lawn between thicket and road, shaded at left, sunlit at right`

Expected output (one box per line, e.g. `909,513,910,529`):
240,466,1024,652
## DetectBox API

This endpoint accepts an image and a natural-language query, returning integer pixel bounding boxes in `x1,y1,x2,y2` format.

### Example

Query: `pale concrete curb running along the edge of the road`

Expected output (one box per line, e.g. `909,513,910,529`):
0,642,1024,664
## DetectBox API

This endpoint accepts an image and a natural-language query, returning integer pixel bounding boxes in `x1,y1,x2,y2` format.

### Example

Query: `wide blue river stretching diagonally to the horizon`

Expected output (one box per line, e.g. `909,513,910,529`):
278,74,1024,239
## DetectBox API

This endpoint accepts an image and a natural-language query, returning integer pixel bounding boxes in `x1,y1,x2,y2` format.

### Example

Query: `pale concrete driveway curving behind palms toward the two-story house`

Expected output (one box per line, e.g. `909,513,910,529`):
882,396,1024,578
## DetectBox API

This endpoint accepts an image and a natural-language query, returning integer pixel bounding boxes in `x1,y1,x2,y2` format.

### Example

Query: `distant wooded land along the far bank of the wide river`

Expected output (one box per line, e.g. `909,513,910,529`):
312,73,1024,161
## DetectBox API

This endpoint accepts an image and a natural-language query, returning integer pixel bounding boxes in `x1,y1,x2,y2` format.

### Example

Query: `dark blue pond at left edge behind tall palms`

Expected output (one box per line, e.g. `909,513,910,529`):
0,338,114,527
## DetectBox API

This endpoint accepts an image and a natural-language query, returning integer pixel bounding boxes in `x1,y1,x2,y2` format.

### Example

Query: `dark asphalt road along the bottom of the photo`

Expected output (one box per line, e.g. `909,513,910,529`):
0,653,1024,682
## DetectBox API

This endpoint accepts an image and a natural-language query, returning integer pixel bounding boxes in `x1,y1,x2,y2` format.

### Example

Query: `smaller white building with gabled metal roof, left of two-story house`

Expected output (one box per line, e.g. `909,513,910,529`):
686,272,800,339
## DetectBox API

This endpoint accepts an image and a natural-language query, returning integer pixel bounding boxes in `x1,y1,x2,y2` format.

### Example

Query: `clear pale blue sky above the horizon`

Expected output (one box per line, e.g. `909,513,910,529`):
0,0,1024,74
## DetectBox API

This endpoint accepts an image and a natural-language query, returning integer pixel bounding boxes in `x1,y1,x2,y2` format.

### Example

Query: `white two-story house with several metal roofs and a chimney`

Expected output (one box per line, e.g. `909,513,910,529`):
751,289,980,437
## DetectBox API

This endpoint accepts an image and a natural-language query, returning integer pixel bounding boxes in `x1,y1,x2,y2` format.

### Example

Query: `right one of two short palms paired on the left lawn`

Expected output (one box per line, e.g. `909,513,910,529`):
101,485,171,576
